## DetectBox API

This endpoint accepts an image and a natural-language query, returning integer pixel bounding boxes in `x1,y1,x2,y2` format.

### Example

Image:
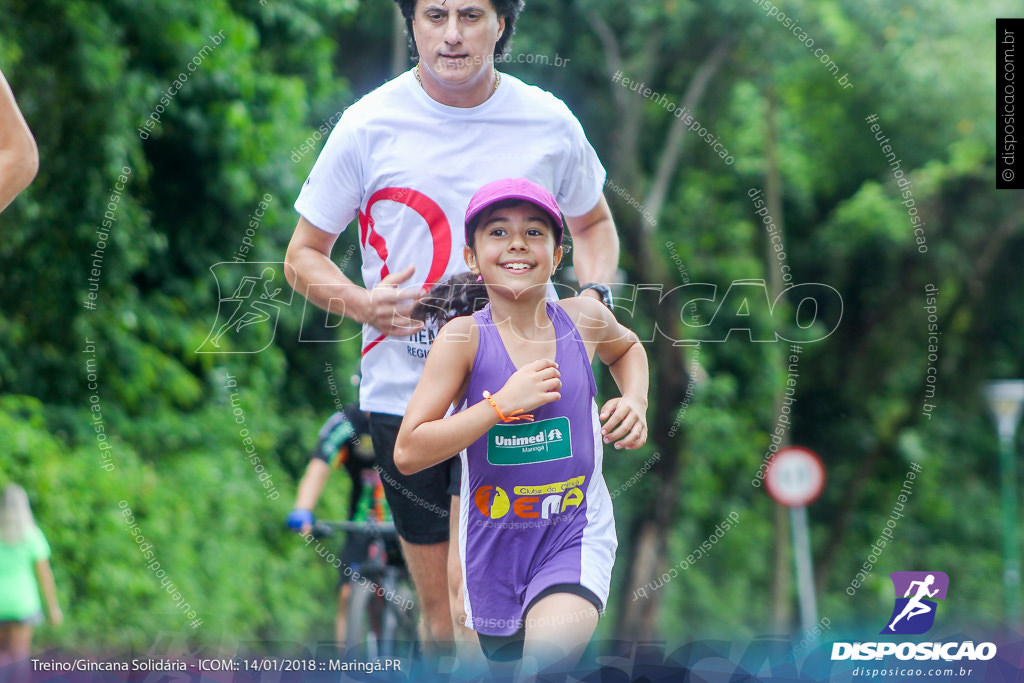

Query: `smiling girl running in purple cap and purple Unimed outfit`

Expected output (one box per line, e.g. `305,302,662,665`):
394,178,648,669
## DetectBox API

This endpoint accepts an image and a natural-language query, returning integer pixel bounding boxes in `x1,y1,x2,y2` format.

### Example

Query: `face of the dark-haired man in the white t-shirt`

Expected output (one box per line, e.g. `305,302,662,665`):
413,0,505,86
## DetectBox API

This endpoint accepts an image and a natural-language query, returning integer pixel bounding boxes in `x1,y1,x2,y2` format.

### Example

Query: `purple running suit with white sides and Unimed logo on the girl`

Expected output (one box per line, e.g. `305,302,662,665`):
459,301,615,635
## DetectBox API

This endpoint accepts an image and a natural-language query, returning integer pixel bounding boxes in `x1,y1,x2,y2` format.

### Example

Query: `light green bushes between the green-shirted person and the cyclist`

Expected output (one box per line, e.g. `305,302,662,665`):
0,396,340,650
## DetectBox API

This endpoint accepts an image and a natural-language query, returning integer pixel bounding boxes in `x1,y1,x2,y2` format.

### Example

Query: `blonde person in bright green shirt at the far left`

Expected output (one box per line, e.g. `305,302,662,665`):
0,483,63,670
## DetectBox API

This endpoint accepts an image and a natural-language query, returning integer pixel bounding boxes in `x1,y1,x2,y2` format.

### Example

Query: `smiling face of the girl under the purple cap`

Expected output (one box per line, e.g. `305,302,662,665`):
464,202,562,298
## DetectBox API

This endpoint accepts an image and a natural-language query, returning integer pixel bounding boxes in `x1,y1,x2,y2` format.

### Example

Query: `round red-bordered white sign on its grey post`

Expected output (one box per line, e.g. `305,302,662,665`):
765,446,825,633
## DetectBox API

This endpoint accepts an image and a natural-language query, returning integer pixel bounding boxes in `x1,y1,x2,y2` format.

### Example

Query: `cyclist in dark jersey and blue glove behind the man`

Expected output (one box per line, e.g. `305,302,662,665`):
288,403,400,646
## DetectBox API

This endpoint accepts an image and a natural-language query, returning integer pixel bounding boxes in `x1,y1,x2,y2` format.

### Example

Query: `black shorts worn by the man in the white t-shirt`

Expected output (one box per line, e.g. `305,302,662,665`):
370,413,452,546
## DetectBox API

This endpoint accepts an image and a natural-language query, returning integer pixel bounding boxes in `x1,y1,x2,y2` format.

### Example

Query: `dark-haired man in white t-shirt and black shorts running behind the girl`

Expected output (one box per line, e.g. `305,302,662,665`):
286,0,618,663
